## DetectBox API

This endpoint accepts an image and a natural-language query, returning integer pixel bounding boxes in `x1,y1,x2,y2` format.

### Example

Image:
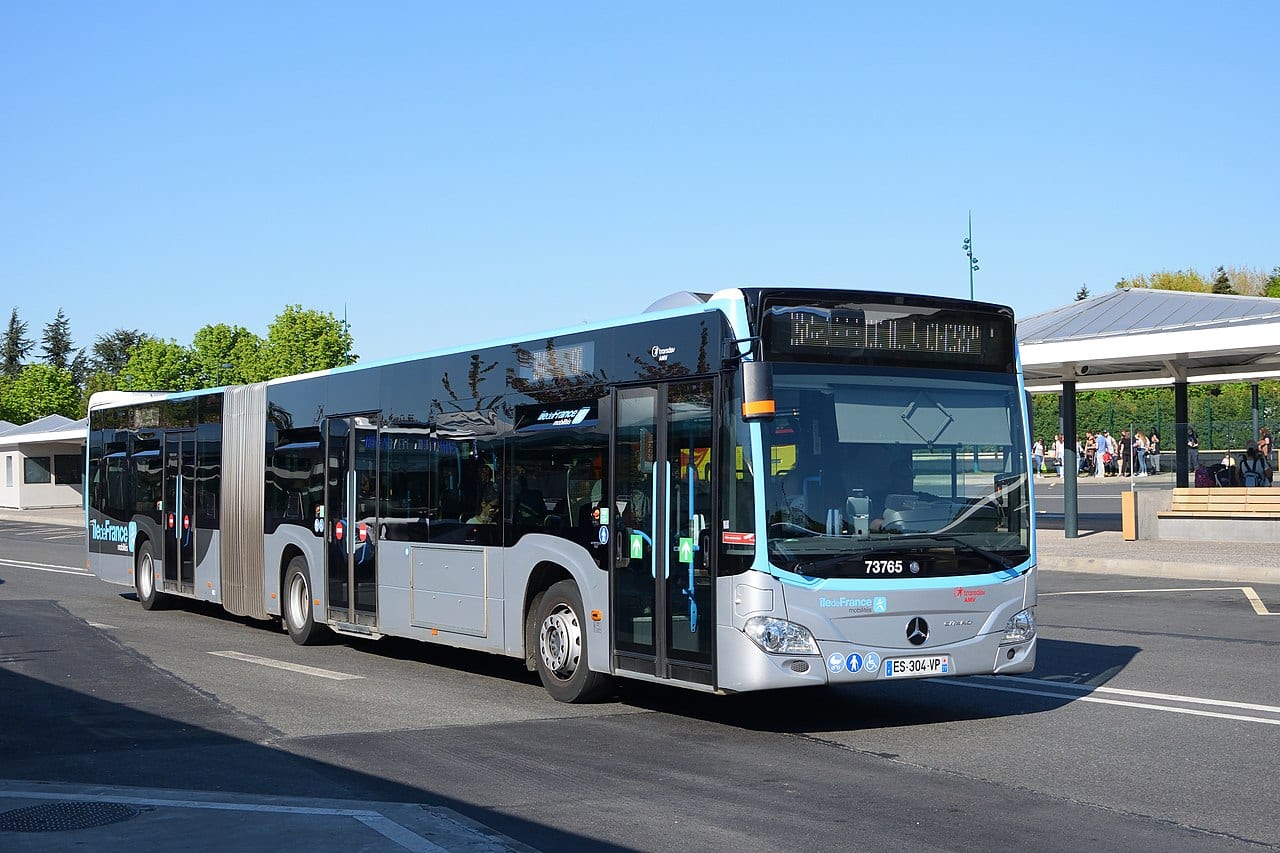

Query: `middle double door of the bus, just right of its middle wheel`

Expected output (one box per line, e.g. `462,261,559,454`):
325,415,378,628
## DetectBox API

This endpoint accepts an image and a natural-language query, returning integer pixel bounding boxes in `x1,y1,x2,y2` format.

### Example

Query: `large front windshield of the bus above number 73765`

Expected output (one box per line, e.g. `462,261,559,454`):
764,364,1030,578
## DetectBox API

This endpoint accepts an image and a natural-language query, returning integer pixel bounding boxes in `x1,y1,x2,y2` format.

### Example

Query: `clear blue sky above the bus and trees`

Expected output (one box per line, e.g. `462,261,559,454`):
0,0,1280,360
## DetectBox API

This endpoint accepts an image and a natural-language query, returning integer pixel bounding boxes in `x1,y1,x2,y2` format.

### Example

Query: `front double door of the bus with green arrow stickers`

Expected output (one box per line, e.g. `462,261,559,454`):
609,379,717,685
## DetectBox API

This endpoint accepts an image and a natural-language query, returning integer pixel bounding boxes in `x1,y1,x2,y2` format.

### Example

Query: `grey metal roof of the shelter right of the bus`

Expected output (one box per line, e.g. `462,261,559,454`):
1018,288,1280,392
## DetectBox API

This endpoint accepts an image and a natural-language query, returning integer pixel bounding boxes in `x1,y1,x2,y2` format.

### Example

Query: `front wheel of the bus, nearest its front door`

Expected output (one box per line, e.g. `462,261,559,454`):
536,580,609,702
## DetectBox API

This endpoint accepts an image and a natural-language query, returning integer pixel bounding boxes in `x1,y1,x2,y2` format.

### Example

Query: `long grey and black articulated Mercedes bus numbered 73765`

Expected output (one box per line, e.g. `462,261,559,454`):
87,288,1036,702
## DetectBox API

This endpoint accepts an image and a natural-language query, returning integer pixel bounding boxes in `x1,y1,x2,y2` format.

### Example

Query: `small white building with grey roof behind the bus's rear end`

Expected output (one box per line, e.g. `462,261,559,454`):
0,415,86,510
